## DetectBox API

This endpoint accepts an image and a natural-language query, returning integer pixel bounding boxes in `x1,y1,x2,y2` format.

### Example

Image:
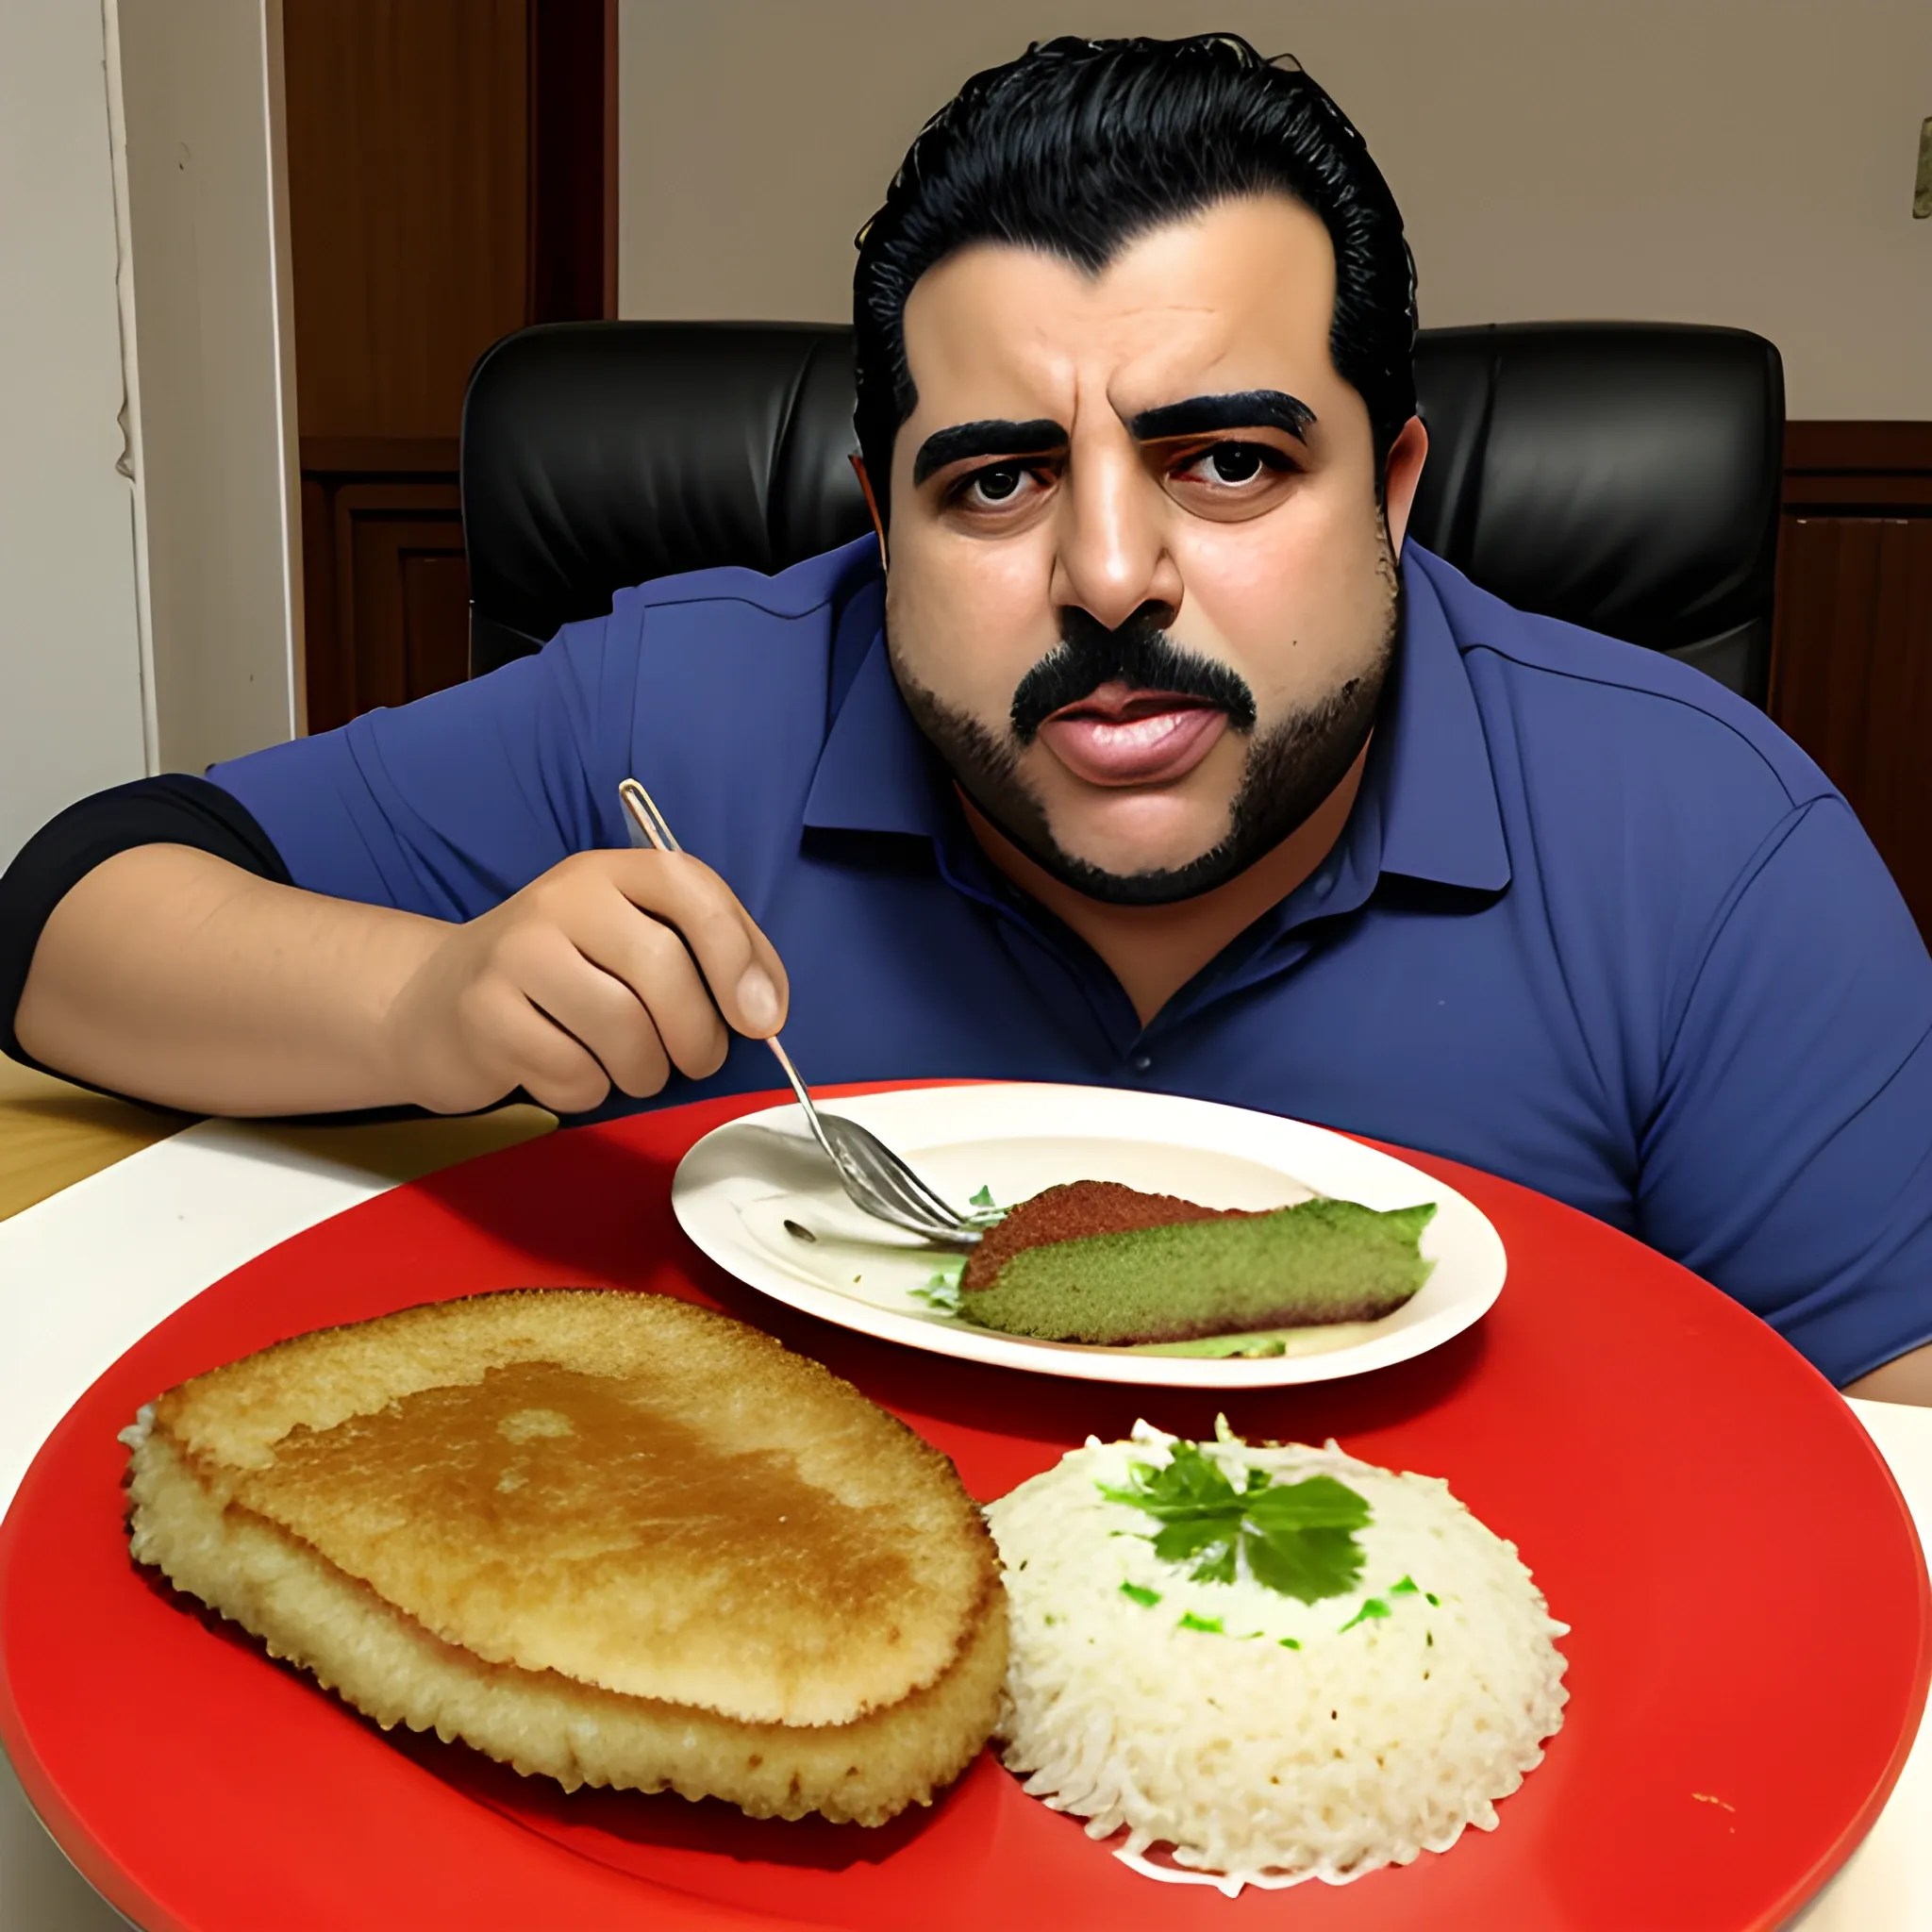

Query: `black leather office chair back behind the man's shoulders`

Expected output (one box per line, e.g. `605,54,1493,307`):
461,323,1783,703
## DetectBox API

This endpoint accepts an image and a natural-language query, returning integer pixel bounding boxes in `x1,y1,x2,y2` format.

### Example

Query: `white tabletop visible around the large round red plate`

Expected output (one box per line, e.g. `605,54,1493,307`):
0,1121,1932,1932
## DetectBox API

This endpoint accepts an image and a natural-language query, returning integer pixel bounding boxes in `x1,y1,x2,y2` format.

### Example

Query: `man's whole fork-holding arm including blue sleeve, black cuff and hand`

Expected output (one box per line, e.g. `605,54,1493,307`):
0,597,808,1113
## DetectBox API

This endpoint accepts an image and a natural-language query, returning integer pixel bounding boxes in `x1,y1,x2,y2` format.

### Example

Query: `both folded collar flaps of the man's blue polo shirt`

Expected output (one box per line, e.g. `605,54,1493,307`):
804,542,1508,892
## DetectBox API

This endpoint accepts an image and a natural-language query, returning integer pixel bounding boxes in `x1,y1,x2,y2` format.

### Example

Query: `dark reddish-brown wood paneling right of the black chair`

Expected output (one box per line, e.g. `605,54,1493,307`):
1770,424,1932,935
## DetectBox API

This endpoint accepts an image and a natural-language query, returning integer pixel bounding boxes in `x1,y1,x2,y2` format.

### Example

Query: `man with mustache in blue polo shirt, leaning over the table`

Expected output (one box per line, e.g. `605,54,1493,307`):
0,37,1932,1399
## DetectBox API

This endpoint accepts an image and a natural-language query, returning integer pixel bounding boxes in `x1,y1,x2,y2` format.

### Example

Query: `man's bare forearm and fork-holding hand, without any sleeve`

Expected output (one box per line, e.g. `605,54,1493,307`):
13,844,784,1115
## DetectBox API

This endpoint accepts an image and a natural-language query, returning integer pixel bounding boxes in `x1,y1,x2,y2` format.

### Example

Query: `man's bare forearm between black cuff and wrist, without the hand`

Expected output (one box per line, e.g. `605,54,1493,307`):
13,844,450,1115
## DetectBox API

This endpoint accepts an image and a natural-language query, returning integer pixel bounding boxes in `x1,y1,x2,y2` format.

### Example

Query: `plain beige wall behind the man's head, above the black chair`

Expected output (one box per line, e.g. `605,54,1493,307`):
618,0,1932,417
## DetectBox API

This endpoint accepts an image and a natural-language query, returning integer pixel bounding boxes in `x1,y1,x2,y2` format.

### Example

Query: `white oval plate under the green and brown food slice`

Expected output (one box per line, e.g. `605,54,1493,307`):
671,1084,1505,1390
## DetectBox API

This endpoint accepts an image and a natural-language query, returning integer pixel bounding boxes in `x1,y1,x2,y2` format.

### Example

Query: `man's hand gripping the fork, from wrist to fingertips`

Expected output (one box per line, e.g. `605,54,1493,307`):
383,852,789,1113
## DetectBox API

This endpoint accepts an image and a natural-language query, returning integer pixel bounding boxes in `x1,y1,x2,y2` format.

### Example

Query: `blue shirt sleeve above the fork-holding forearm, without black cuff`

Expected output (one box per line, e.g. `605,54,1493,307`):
208,614,638,920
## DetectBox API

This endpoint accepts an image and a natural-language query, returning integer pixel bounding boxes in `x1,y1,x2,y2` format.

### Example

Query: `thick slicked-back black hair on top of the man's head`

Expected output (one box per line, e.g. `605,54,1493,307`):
852,33,1416,516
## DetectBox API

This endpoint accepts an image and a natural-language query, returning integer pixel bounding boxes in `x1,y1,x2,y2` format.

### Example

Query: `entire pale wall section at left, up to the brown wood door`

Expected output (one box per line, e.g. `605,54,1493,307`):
0,0,301,866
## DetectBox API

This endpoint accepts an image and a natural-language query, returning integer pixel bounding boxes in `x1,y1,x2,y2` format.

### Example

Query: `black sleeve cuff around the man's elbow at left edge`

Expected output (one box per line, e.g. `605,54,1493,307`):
0,771,293,1078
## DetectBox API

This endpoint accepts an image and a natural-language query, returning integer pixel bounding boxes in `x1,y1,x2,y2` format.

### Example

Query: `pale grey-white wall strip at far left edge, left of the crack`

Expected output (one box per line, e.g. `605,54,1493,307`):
0,0,147,863
